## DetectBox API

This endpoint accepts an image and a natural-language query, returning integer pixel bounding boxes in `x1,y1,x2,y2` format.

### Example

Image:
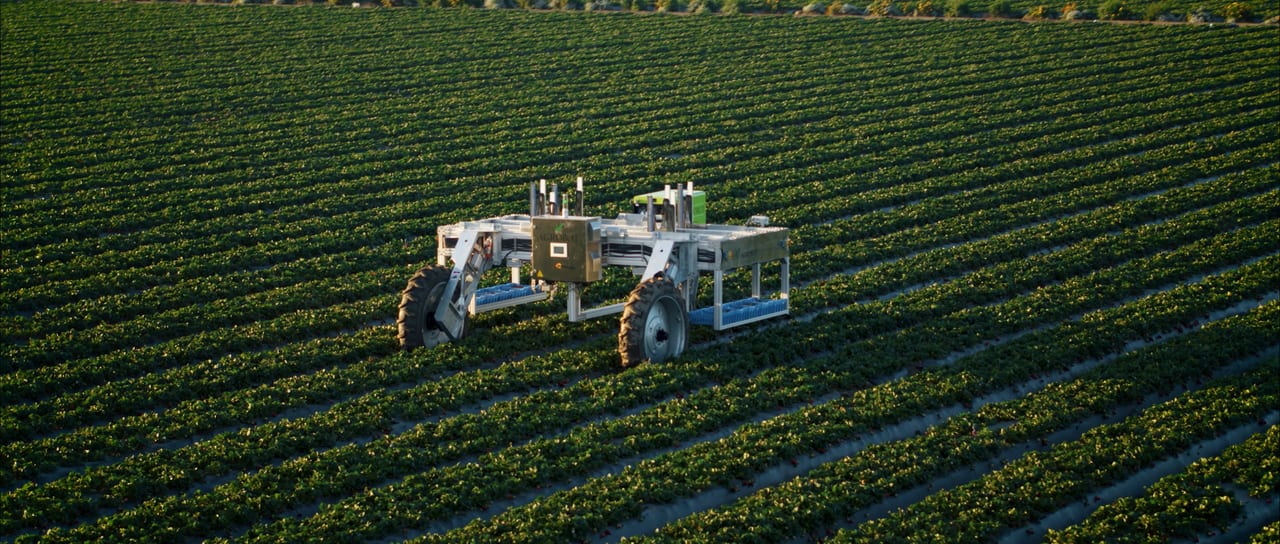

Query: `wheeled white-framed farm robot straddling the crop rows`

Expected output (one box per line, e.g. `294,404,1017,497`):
397,178,791,366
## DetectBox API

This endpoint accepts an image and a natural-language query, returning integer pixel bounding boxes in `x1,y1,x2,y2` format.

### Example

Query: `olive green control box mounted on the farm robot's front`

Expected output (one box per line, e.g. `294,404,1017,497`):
532,216,604,283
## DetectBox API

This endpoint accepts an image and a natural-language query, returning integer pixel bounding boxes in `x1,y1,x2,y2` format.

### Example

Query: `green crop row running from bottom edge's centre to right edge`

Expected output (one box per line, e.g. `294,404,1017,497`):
643,303,1280,541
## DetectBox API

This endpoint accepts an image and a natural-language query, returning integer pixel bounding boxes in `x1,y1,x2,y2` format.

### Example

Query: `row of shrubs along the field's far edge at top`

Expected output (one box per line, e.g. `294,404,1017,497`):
142,0,1280,24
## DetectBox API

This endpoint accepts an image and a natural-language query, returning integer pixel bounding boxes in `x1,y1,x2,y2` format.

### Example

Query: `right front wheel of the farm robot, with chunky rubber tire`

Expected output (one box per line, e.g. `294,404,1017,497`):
618,276,689,367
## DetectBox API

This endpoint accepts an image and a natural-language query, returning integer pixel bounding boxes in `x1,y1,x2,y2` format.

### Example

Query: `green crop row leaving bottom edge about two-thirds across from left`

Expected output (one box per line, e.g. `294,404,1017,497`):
832,364,1280,543
